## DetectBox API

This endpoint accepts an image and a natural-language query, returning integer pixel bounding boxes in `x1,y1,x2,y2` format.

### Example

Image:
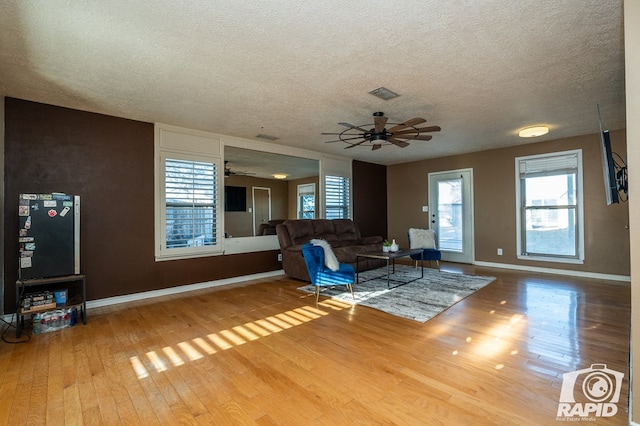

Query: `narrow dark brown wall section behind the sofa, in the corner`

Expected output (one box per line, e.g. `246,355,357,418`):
351,160,387,238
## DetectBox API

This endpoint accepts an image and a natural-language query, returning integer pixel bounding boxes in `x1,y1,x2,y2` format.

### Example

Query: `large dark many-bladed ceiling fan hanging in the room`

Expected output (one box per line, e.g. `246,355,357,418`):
322,112,441,151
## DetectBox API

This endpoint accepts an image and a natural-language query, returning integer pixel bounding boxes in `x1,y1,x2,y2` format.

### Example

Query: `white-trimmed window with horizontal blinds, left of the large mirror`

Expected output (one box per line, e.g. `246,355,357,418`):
154,123,224,261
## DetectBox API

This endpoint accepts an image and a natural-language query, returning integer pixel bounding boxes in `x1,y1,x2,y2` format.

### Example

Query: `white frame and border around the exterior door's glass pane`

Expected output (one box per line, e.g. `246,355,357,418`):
428,168,475,264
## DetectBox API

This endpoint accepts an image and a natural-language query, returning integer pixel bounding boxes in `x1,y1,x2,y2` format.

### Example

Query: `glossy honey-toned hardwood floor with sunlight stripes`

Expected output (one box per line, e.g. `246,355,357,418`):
0,264,630,425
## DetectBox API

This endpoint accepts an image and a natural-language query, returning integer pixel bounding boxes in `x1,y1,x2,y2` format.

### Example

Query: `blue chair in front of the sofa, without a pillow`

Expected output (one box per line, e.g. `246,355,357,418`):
302,244,356,303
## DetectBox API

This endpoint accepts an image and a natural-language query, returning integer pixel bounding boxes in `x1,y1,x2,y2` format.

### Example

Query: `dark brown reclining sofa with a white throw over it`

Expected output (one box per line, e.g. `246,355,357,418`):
276,219,385,281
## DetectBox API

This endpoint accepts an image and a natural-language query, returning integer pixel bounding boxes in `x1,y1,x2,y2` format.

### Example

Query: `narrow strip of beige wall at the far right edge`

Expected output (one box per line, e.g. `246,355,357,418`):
624,0,640,424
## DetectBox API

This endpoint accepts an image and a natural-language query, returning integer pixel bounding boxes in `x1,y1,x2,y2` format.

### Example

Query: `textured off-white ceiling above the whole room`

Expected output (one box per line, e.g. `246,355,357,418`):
0,0,625,164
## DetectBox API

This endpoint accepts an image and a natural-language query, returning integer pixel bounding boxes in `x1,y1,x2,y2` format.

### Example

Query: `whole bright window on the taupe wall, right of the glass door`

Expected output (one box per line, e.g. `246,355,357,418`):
516,150,584,263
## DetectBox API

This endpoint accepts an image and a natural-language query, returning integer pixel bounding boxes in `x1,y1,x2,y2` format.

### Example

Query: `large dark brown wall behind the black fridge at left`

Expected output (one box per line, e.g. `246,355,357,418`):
4,98,281,312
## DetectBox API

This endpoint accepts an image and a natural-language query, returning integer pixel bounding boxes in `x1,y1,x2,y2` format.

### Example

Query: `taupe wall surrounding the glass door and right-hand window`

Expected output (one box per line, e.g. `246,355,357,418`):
387,129,630,276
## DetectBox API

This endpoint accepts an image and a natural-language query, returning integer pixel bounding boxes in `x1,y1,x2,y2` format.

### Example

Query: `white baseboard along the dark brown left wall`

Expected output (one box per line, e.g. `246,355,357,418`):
87,269,284,309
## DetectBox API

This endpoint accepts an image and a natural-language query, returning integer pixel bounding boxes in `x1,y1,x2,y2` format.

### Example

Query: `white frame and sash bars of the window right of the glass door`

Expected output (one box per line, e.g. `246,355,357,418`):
515,149,584,264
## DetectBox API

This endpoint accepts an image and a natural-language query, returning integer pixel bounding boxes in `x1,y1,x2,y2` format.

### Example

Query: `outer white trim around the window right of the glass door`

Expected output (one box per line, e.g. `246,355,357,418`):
515,149,584,264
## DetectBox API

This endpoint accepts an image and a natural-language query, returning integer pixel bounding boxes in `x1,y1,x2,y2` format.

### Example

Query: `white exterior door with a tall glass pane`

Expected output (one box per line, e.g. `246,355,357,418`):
429,169,474,263
